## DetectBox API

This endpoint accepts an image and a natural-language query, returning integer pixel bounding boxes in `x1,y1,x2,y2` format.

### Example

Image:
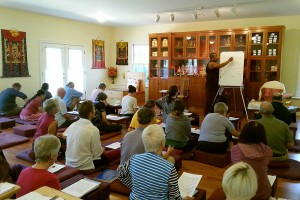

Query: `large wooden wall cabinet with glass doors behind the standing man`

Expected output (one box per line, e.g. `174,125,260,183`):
149,26,285,109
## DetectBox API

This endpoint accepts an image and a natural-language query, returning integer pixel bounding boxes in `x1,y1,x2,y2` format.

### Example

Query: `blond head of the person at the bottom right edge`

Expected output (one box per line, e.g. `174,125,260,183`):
222,162,258,200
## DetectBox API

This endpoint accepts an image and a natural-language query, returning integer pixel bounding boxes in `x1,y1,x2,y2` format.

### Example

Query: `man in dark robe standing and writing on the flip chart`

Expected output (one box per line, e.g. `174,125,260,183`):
204,52,233,115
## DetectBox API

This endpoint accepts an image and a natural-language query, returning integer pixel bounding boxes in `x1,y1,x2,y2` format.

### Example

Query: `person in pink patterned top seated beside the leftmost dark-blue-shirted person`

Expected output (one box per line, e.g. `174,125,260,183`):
20,90,45,121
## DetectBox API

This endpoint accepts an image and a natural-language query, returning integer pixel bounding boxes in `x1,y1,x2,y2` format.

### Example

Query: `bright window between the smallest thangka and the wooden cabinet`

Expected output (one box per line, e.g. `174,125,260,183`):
132,44,149,87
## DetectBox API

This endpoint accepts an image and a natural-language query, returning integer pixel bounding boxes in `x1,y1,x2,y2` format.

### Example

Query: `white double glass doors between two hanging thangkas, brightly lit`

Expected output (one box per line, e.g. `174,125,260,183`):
41,42,86,98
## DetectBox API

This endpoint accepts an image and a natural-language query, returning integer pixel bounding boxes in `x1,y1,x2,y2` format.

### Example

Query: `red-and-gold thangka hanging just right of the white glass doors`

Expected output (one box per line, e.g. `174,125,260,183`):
92,40,105,69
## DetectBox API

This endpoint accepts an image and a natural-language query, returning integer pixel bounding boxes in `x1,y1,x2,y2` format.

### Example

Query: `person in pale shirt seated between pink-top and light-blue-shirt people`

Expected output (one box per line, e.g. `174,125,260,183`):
54,88,79,128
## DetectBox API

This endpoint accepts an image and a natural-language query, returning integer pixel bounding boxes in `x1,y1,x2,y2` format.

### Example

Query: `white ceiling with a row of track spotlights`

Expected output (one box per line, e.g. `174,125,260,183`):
0,0,300,27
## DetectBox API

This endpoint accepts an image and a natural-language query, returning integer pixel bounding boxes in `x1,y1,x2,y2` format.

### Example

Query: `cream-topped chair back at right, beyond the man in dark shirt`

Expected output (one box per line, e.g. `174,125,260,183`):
258,81,285,101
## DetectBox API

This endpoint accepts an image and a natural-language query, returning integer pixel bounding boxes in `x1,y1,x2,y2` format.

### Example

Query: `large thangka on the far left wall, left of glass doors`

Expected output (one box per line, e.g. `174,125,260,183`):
1,29,30,78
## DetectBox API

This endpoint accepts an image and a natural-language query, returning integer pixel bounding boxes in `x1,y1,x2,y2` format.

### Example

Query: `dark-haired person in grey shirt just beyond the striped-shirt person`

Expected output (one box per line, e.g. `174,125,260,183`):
120,107,154,164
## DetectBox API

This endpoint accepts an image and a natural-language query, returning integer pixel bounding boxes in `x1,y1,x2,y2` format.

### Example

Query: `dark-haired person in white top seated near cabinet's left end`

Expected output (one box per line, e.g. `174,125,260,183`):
120,85,137,118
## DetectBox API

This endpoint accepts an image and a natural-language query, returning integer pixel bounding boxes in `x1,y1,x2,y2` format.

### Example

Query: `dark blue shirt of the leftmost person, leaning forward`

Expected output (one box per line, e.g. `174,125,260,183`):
0,88,27,112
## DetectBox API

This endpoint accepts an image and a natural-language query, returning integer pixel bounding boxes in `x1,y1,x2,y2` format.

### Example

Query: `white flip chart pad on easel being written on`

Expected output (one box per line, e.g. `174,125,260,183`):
219,51,244,86
